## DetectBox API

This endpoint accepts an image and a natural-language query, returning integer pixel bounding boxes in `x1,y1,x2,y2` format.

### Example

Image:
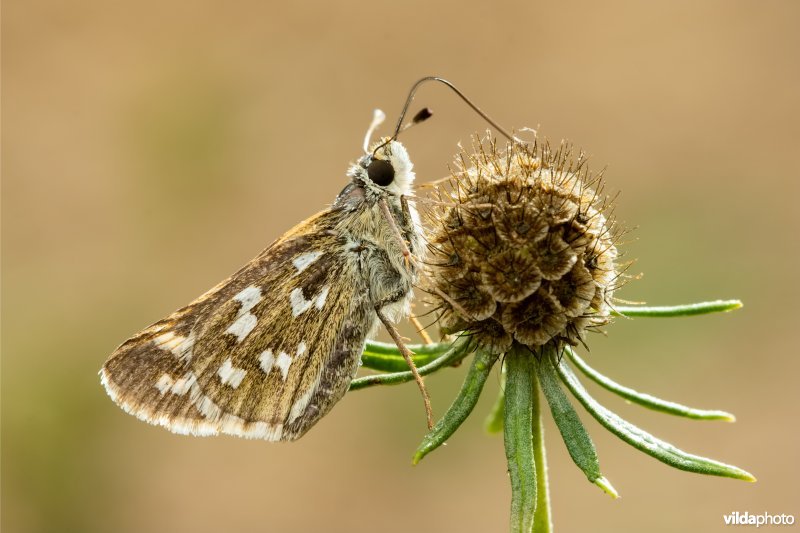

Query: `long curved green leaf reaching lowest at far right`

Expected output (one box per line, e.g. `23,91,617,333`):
554,359,755,481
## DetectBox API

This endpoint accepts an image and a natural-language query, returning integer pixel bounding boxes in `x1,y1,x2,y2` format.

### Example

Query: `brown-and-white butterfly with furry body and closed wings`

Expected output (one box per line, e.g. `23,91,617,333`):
100,141,423,441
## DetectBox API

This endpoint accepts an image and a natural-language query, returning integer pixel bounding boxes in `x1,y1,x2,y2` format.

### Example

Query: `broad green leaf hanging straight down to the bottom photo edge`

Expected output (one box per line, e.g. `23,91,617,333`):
503,346,537,533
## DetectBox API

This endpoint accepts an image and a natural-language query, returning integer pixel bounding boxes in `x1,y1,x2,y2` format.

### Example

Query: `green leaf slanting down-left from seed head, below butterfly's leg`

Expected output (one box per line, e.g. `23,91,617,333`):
413,350,498,464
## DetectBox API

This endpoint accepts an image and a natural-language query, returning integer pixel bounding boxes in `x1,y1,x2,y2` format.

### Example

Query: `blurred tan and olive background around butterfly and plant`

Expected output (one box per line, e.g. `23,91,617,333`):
2,0,800,533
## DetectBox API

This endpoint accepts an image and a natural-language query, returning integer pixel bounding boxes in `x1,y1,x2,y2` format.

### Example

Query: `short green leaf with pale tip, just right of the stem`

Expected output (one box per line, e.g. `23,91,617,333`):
536,349,616,495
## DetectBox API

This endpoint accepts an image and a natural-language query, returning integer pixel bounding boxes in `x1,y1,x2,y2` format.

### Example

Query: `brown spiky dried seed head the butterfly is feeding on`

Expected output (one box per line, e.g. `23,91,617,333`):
428,133,619,353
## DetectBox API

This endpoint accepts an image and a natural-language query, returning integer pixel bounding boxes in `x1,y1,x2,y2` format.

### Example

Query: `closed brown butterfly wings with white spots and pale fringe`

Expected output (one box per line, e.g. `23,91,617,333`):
100,208,376,441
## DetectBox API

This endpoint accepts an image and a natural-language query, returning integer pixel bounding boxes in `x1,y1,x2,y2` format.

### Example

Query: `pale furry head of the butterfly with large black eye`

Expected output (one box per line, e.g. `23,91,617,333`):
348,139,414,196
